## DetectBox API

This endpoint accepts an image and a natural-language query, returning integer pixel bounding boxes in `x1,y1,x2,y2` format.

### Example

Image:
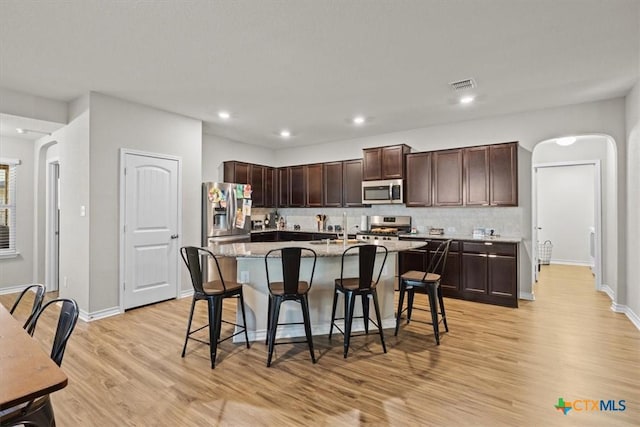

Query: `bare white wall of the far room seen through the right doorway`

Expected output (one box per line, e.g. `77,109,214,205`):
534,166,595,265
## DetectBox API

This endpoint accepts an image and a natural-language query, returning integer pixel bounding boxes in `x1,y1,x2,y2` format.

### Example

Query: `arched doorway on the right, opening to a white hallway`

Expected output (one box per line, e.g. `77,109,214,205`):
532,134,617,299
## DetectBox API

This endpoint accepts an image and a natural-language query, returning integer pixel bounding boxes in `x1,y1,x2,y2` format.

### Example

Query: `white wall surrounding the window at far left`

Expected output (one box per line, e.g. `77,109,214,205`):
0,136,34,293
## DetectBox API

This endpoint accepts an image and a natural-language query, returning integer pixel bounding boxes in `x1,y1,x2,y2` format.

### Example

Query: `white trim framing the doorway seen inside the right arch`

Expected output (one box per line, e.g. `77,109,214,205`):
531,160,606,292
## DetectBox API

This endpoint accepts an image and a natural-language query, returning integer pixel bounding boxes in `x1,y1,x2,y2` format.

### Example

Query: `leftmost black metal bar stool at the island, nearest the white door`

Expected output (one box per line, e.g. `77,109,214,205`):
180,246,249,369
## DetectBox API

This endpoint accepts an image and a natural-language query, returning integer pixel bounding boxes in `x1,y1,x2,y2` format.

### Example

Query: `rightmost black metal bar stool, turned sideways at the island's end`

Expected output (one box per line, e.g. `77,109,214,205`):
395,240,451,345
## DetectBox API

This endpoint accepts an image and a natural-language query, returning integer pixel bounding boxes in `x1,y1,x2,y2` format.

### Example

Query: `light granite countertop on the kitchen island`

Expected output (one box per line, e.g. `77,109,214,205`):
209,240,424,258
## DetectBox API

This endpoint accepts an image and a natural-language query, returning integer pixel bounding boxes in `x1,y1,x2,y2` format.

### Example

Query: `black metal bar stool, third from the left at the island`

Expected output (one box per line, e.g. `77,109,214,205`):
329,245,388,358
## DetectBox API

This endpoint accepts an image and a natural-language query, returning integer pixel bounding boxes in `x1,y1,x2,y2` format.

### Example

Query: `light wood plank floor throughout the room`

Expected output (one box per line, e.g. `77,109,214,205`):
5,266,640,427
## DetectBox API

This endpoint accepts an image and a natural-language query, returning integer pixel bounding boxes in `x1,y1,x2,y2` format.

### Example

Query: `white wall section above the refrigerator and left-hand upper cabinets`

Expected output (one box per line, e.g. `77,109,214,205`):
202,134,276,182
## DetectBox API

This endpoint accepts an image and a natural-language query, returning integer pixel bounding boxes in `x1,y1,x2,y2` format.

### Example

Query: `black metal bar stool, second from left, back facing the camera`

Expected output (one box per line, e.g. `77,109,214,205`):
264,247,317,366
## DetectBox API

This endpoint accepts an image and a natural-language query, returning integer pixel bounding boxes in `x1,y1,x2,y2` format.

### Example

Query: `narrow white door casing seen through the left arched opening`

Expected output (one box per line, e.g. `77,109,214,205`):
44,157,60,292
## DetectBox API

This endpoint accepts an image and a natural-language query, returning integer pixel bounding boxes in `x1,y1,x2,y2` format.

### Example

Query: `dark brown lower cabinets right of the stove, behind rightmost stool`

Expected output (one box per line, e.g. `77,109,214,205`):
398,239,518,307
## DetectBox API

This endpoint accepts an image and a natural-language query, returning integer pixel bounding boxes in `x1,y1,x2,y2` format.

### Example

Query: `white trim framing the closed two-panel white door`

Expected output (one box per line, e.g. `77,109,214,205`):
118,148,182,313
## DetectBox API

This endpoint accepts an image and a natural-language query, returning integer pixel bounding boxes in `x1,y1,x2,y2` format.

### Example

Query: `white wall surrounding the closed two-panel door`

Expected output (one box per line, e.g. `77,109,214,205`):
89,93,202,312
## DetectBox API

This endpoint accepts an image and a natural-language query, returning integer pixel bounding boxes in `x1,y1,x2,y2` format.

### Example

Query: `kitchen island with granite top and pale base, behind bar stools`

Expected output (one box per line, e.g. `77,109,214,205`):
209,241,424,342
